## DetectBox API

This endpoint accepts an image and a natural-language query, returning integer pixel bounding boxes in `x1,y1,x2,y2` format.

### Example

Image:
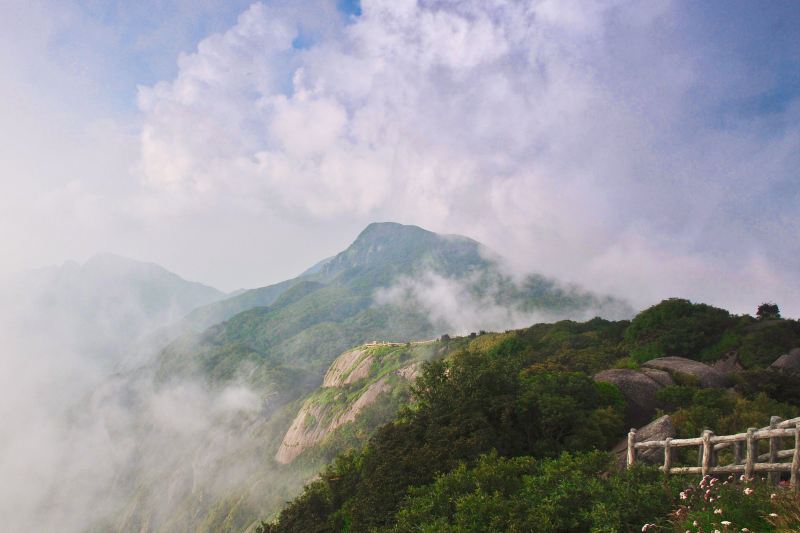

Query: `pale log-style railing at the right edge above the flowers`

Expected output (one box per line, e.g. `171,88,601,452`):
627,416,800,491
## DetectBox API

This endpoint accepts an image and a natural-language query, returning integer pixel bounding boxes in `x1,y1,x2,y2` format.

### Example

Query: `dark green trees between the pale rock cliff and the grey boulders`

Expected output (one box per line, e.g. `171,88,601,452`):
262,338,636,531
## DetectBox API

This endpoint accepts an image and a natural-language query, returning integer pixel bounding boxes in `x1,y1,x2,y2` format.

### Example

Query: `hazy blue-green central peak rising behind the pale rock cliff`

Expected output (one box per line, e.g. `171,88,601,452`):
158,222,632,394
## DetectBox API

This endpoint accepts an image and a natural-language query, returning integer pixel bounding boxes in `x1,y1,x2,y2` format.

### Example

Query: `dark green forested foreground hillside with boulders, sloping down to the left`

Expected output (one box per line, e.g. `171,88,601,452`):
261,299,800,532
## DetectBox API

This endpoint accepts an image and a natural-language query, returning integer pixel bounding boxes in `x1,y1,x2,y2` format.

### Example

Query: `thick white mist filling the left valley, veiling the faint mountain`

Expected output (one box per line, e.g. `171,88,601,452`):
0,256,276,531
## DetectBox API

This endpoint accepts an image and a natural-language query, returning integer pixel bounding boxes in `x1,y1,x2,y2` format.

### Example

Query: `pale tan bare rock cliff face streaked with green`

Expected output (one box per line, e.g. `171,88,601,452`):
275,343,431,464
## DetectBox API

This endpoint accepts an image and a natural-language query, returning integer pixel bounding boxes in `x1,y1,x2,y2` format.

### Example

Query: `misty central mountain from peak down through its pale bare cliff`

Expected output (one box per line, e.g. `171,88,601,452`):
98,223,632,531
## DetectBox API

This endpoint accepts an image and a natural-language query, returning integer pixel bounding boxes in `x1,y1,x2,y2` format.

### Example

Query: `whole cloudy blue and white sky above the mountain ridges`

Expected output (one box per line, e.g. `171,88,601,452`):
0,0,800,316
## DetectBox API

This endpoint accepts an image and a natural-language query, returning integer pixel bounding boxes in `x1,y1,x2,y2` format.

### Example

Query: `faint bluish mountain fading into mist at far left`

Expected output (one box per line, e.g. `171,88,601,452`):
0,254,225,362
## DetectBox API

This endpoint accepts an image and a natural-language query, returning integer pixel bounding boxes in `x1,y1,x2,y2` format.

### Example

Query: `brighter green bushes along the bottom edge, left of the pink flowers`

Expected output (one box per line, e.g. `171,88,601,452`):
390,452,675,533
